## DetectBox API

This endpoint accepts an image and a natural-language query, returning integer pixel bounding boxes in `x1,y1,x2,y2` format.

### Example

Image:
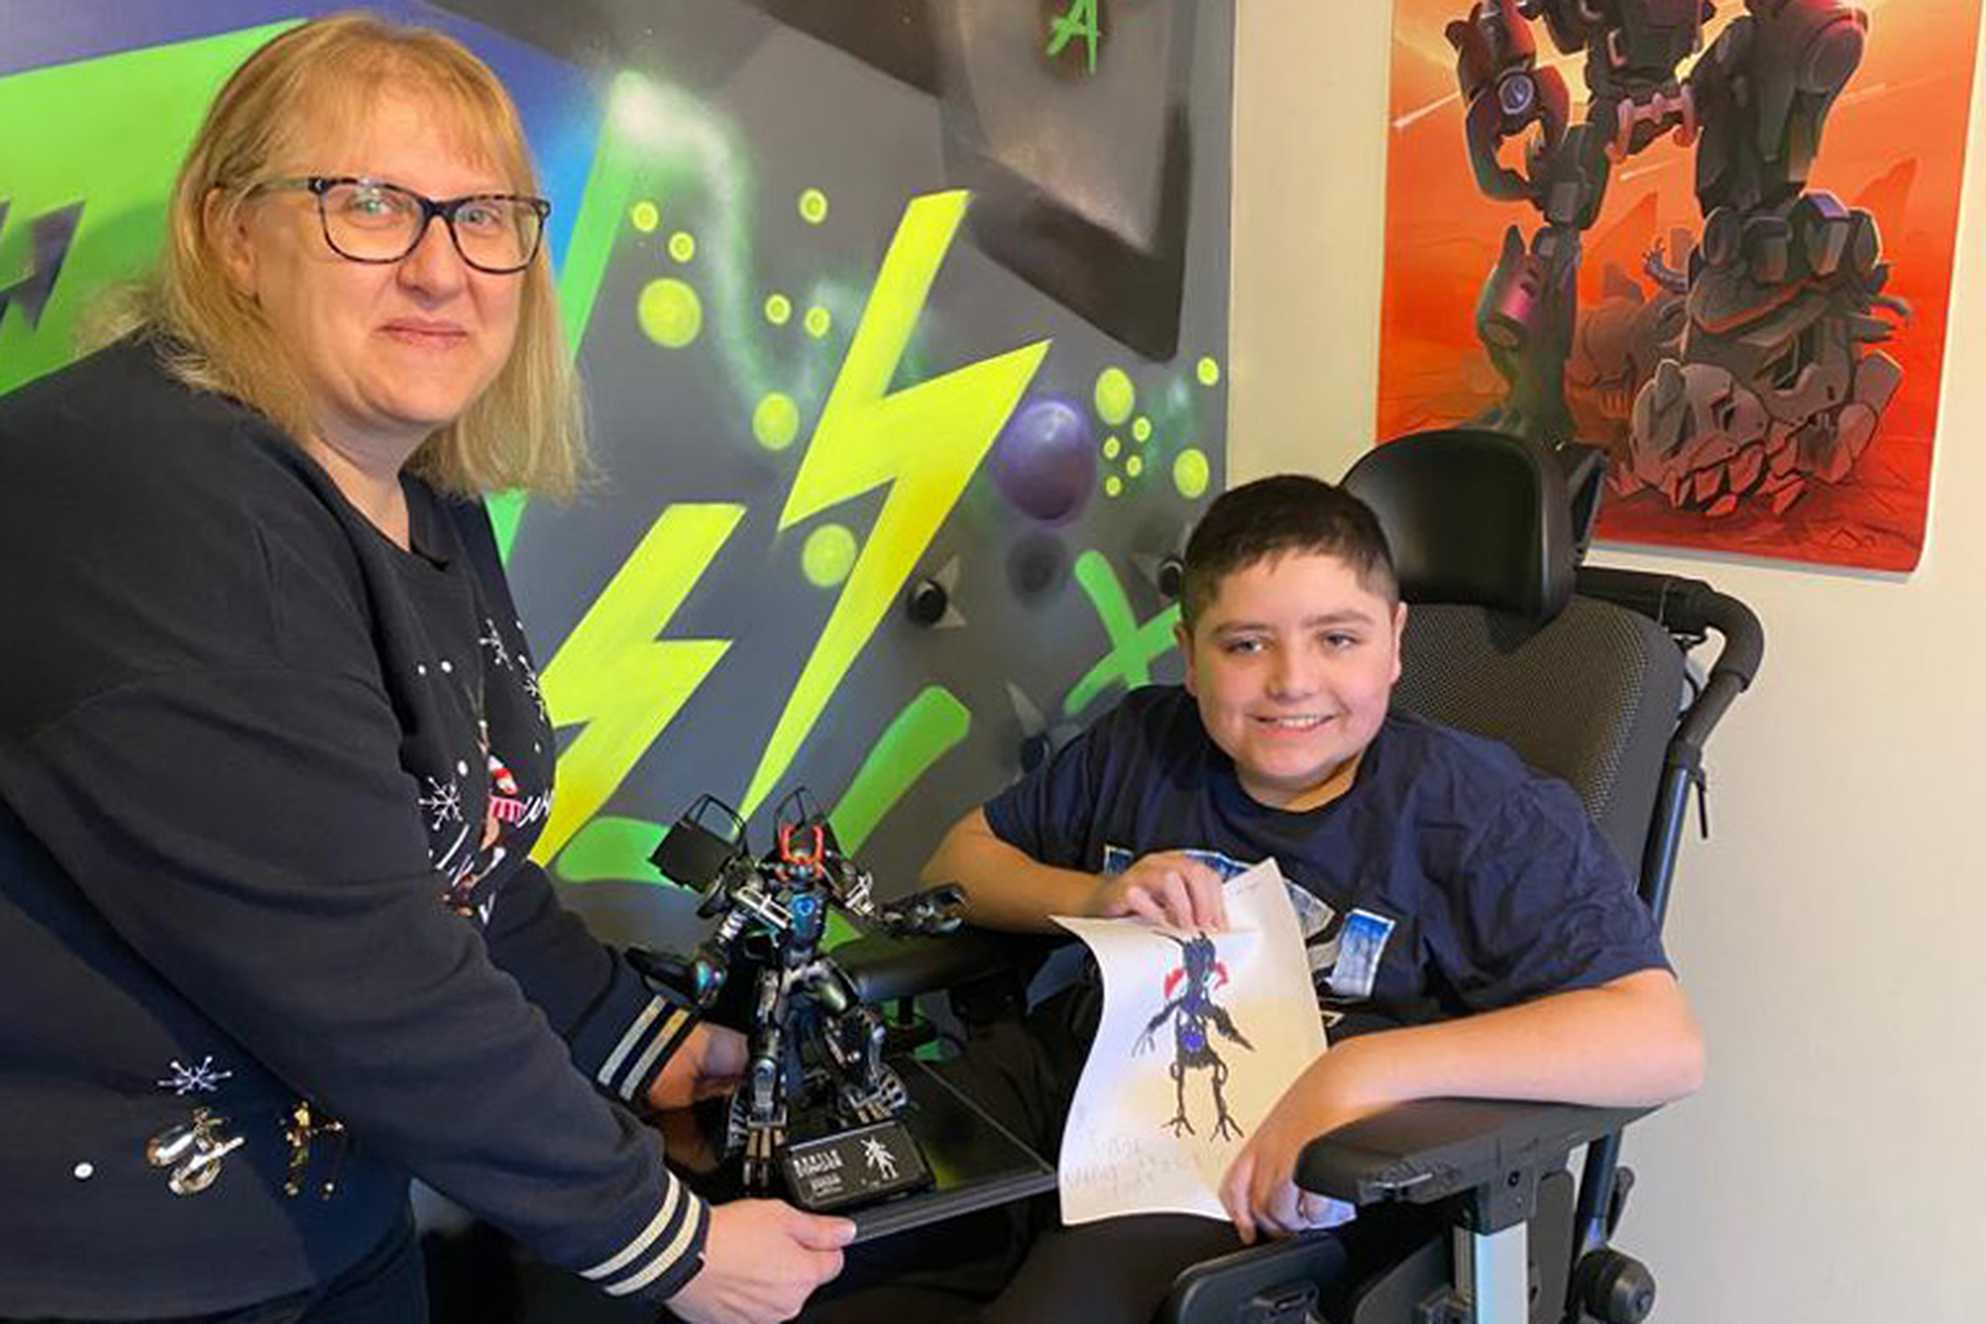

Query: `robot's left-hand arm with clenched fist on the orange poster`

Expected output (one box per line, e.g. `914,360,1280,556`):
1446,0,1571,200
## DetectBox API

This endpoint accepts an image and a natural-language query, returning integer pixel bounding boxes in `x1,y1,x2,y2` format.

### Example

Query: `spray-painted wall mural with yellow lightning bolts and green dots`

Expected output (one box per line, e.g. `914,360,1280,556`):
0,0,1233,943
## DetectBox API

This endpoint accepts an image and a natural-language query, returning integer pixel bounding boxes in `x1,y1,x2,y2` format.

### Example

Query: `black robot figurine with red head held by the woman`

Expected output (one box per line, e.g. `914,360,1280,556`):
638,790,965,1209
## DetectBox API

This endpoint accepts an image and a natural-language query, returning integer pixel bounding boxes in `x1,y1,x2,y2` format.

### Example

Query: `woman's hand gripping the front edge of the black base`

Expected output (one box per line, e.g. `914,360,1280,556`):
669,1199,856,1324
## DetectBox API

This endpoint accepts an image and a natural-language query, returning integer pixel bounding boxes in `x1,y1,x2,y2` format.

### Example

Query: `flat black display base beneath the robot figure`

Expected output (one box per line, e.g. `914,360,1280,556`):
669,1058,1055,1243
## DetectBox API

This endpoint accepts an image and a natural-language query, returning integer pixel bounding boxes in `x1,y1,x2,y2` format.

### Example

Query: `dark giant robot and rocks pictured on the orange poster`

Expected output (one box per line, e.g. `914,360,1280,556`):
1446,0,1911,516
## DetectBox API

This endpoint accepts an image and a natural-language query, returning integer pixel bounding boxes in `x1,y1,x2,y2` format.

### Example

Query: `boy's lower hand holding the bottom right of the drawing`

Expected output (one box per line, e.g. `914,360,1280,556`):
1221,1044,1378,1245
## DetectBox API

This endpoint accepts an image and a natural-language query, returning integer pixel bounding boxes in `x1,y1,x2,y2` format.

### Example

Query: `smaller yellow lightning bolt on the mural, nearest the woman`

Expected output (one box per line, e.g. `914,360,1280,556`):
530,502,745,863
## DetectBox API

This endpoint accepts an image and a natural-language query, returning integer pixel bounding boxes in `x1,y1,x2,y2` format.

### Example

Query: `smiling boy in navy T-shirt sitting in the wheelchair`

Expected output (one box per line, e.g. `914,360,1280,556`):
810,474,1702,1324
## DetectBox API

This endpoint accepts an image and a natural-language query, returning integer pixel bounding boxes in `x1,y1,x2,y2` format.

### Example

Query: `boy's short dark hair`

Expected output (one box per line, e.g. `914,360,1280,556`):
1180,474,1400,629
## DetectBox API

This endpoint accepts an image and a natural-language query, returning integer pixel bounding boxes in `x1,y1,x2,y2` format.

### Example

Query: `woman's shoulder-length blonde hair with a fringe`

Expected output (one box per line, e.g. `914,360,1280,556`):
89,12,586,496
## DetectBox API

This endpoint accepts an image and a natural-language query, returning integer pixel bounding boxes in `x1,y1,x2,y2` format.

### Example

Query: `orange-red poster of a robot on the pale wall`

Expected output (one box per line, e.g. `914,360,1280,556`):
1378,0,1980,570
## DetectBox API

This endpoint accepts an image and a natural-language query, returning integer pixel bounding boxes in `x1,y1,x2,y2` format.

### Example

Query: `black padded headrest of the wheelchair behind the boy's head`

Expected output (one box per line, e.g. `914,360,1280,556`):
1343,429,1603,625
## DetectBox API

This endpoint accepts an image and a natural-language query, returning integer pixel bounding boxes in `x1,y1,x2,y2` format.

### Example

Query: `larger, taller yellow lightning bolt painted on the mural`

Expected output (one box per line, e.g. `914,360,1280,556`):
743,191,1049,816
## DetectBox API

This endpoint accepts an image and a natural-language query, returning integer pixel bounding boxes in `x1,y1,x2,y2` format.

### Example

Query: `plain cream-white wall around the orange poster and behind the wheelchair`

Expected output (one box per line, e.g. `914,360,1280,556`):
1229,0,1986,1324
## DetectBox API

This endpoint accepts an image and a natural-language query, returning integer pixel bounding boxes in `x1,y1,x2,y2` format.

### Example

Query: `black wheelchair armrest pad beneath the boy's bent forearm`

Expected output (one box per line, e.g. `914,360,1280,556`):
1297,1100,1654,1231
